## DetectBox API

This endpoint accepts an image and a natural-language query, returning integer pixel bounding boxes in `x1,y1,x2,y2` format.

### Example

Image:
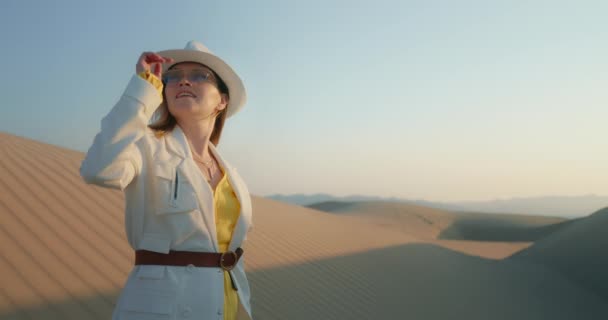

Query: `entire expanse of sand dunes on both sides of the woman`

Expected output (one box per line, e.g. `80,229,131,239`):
0,133,608,320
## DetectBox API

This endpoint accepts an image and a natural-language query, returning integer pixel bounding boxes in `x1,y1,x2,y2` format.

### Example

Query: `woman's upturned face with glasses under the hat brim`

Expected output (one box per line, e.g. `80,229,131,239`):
162,62,227,123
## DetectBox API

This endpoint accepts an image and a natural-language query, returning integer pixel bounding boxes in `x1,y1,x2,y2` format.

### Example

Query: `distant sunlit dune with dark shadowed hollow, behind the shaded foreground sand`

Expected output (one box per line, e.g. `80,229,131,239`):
307,201,569,259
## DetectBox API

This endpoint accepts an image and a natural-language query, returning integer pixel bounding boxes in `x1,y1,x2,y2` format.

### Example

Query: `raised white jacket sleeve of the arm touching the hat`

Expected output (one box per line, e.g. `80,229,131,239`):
80,75,162,190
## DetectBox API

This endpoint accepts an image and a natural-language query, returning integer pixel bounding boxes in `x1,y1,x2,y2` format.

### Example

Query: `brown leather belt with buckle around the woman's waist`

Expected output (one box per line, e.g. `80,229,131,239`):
135,248,243,271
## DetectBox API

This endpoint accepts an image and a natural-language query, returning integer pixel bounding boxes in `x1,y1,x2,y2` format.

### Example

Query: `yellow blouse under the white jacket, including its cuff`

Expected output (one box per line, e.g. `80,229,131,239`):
139,71,241,320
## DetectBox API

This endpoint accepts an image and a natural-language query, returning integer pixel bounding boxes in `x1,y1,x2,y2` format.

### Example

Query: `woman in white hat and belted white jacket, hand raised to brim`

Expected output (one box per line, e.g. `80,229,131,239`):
80,41,252,320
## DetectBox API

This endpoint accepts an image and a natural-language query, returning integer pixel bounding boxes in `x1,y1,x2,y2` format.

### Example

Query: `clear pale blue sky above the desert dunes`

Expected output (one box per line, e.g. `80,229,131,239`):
0,0,608,201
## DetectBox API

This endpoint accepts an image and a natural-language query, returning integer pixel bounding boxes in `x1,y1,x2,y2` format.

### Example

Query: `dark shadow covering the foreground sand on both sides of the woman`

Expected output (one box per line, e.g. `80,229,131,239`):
0,244,608,320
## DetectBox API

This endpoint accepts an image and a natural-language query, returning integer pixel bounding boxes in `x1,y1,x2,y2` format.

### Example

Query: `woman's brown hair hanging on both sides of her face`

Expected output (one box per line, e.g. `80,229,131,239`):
148,65,230,146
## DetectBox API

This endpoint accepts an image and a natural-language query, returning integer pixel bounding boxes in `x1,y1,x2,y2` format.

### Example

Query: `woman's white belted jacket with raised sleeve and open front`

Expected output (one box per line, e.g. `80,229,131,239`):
80,75,252,320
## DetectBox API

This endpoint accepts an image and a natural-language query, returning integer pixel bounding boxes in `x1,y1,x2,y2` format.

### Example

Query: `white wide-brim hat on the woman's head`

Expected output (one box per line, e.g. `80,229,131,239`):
157,40,247,117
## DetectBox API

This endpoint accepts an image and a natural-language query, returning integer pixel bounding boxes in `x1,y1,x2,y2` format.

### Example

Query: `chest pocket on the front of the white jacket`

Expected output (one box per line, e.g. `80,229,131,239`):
155,164,198,214
